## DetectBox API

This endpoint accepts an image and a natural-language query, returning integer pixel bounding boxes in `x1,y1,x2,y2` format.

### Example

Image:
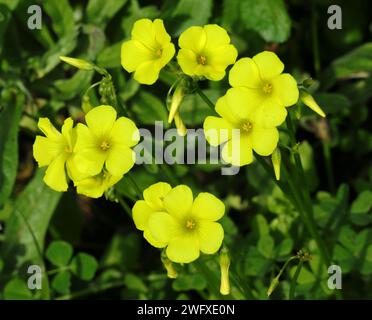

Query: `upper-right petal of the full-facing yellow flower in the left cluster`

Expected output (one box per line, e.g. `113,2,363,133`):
109,117,140,147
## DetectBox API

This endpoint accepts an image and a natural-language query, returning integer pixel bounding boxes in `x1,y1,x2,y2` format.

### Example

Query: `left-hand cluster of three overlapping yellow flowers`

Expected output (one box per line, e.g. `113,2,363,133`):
33,105,139,198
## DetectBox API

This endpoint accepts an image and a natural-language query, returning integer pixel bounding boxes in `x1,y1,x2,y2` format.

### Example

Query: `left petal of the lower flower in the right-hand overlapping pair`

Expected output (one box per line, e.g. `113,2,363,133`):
203,116,233,146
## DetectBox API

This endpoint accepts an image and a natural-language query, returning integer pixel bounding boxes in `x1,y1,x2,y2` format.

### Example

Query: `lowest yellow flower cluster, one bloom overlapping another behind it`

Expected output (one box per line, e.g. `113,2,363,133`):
133,182,225,263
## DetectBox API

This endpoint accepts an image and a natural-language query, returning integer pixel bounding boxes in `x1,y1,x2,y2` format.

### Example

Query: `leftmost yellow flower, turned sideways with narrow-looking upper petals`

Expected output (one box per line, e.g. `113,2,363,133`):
33,118,76,192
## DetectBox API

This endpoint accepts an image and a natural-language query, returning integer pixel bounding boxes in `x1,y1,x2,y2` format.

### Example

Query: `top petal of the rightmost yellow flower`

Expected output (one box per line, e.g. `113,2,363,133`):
253,51,284,80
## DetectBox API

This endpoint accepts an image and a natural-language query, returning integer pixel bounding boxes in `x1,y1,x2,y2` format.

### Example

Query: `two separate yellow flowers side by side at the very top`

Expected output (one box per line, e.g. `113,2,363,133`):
121,19,238,84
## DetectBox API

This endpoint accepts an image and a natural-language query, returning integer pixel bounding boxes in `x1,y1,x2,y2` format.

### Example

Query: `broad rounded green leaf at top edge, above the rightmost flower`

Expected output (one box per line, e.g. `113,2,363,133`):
241,0,291,43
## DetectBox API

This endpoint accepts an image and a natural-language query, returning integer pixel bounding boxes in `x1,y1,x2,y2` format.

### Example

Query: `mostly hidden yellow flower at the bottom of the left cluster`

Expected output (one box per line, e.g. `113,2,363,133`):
75,170,122,198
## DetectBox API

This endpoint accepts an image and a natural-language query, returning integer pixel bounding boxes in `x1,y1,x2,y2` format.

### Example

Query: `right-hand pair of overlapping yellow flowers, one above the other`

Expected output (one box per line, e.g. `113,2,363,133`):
204,51,299,166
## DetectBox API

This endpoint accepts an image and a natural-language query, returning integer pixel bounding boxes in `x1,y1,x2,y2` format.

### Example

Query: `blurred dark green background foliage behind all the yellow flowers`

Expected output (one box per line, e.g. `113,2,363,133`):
0,0,372,299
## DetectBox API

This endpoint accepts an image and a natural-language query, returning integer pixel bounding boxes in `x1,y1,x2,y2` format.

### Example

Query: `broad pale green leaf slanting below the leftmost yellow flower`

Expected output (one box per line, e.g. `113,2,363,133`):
3,169,62,272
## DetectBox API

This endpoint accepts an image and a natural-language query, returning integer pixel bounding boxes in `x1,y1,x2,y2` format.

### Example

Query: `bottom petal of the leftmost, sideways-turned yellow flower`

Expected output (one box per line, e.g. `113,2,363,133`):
44,155,68,192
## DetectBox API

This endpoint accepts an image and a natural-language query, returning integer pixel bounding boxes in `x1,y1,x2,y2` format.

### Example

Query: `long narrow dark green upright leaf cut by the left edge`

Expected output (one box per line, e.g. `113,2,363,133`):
0,89,25,208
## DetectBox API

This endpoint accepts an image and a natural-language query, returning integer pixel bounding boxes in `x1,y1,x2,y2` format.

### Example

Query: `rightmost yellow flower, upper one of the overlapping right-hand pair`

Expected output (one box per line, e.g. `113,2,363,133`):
229,51,299,127
